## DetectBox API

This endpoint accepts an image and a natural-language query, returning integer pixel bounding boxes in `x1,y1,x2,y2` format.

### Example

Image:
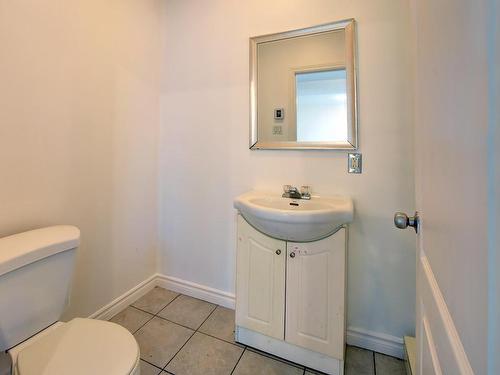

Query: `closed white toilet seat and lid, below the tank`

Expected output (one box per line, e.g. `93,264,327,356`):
15,318,140,375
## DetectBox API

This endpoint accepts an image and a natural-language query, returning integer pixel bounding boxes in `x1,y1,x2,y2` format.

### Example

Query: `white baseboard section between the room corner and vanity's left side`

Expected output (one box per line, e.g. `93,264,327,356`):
156,274,236,309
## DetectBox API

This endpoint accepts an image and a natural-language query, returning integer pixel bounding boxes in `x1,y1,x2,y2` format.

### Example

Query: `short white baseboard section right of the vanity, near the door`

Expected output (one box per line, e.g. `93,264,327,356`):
346,327,404,358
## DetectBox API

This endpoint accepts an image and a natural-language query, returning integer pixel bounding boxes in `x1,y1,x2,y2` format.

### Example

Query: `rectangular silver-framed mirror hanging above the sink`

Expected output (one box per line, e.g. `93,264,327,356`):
250,19,357,150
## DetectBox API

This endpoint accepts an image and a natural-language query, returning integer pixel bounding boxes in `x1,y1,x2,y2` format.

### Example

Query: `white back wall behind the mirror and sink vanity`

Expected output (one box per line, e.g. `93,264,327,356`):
160,0,415,342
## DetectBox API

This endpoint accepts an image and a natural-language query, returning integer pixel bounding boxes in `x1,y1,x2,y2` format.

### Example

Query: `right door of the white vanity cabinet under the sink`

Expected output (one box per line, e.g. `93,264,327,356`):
285,228,346,360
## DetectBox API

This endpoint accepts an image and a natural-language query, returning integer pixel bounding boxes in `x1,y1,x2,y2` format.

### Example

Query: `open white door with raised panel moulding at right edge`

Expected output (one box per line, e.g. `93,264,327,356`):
414,0,499,375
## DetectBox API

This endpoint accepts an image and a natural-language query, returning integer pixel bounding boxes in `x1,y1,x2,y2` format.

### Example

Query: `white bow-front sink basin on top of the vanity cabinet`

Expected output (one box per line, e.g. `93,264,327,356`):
234,191,353,242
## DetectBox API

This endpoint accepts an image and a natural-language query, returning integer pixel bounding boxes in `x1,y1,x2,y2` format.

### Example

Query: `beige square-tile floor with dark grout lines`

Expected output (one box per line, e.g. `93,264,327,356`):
111,287,405,375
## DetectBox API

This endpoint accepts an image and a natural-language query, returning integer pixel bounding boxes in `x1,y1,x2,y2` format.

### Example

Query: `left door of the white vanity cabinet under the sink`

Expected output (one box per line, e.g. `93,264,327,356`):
236,215,286,340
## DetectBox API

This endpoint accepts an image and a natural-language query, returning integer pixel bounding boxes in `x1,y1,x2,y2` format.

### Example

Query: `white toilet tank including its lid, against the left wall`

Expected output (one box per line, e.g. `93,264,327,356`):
0,225,80,351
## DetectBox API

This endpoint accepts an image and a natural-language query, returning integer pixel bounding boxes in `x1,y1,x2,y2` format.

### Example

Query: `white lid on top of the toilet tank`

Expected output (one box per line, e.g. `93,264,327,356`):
0,225,80,276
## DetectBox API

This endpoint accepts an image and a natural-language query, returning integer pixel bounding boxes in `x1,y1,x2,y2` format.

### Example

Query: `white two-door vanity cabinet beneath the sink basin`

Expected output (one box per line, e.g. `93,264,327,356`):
236,215,346,374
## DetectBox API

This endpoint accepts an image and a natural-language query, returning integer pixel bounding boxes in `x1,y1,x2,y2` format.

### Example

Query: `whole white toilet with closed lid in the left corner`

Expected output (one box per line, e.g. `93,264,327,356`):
0,225,140,375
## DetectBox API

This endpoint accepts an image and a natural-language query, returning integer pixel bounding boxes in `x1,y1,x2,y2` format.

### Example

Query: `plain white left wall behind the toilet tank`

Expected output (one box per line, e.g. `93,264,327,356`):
0,0,163,317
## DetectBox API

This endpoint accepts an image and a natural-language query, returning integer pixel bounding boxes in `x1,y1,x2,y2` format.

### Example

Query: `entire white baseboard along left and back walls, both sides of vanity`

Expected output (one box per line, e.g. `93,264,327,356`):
89,273,404,358
